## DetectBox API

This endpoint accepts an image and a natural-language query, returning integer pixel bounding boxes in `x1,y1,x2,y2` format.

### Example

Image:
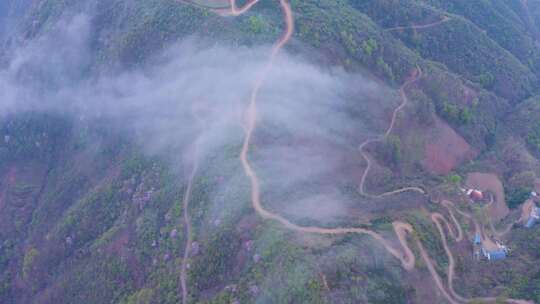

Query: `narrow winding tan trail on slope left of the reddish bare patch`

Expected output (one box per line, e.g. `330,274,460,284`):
358,67,426,198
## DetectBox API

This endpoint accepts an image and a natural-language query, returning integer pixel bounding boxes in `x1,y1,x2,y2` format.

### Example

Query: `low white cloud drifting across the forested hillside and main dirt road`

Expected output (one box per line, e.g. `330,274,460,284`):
0,11,393,223
